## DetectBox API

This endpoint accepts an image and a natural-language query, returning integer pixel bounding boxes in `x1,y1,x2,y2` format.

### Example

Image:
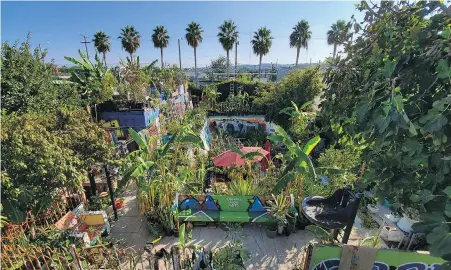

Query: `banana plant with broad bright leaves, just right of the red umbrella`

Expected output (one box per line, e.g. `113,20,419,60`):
268,125,321,194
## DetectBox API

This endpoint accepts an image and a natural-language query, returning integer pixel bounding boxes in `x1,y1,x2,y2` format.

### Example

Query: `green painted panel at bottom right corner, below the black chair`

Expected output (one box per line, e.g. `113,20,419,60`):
309,246,445,270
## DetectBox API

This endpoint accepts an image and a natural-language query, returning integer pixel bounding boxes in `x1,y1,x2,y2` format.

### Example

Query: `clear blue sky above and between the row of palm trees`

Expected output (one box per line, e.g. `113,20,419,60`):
1,1,363,67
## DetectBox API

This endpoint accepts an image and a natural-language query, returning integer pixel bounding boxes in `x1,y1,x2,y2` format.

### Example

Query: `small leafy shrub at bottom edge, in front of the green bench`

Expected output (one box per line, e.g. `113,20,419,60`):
213,240,250,270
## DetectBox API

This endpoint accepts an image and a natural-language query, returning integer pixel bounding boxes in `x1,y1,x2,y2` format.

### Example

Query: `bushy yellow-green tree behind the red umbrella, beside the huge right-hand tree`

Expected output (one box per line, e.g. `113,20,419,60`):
253,67,324,127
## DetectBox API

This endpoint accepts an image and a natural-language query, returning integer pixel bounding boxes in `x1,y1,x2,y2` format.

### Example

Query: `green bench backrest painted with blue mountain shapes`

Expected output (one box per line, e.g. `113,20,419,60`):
173,194,296,223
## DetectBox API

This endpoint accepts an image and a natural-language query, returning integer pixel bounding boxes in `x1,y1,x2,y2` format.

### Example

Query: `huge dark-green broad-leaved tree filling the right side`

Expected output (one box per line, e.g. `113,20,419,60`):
321,2,451,259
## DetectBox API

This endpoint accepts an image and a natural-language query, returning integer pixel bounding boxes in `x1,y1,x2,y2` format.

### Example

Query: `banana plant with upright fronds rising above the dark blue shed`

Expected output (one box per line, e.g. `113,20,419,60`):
64,50,117,104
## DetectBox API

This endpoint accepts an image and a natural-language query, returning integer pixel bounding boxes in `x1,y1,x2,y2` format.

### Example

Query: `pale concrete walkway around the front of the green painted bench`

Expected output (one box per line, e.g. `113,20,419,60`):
111,189,314,270
